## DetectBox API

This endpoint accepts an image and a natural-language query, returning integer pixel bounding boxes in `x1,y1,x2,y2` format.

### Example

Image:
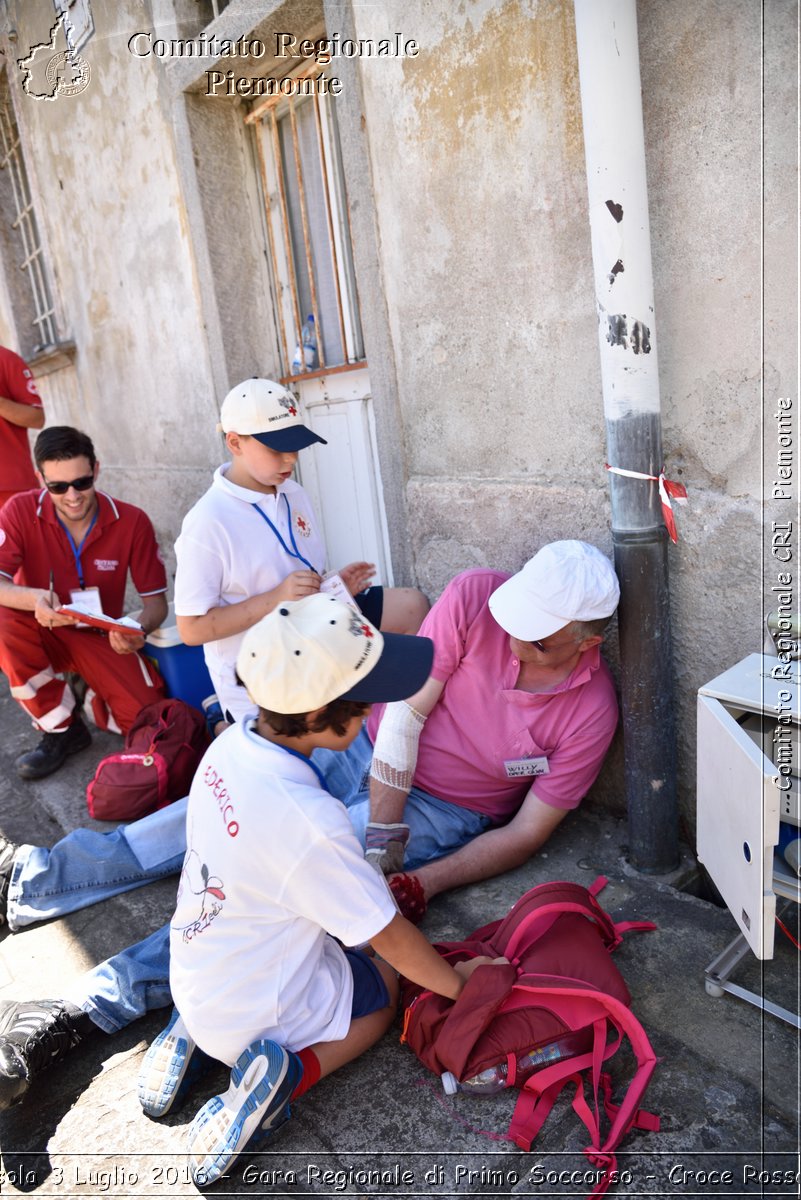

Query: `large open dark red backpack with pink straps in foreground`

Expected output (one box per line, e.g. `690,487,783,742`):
401,878,660,1195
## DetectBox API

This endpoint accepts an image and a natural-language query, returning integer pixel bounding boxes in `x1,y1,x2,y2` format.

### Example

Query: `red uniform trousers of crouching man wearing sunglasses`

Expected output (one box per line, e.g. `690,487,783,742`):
0,605,164,733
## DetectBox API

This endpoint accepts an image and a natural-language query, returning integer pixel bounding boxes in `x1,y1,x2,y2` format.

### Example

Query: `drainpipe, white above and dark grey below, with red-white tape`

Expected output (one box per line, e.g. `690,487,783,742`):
574,0,679,874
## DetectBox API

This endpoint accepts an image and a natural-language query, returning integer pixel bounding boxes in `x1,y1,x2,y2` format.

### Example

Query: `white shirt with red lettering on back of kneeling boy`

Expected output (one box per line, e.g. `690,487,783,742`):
170,721,396,1064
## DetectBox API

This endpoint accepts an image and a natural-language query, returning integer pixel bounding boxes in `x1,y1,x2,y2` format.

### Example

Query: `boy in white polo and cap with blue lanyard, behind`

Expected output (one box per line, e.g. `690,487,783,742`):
175,379,428,720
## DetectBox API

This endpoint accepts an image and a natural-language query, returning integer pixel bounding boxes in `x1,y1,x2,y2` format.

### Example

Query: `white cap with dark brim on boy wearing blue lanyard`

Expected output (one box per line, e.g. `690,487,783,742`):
217,378,326,451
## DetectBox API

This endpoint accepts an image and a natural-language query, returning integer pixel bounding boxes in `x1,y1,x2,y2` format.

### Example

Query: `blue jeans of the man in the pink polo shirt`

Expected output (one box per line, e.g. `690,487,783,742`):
7,728,490,1033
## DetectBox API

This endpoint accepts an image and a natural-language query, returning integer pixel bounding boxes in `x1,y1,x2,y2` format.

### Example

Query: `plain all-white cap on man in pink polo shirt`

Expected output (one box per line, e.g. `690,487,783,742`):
489,541,620,642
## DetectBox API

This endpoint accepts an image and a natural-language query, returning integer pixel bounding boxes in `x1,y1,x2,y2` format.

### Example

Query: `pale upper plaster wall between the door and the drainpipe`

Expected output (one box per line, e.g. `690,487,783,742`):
356,0,603,484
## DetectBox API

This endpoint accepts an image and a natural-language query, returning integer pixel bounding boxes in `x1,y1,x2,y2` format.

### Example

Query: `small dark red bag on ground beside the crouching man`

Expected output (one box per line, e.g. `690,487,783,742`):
86,700,209,821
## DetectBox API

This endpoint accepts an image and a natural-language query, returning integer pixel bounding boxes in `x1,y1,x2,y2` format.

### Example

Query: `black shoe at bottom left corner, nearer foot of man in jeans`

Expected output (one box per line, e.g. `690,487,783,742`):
0,1000,97,1109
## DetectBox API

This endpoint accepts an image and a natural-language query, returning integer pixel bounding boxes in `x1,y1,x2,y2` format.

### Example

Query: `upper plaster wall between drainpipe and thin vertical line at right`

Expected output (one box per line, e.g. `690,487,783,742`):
638,0,762,500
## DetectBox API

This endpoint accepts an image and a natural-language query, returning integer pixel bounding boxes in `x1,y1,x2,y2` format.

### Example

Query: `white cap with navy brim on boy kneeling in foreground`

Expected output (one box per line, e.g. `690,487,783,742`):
236,592,434,713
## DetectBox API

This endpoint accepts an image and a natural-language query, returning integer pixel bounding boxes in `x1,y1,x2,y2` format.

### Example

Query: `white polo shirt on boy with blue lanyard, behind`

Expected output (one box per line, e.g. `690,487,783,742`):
175,463,325,718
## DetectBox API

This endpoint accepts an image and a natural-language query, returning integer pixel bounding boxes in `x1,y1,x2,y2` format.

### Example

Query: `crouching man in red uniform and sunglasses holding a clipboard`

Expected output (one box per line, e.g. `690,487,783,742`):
0,425,167,779
